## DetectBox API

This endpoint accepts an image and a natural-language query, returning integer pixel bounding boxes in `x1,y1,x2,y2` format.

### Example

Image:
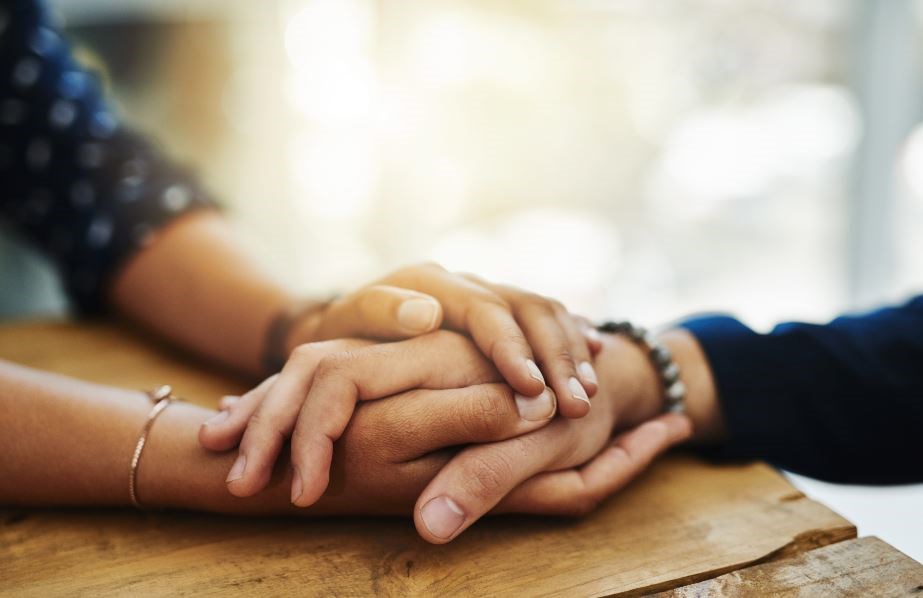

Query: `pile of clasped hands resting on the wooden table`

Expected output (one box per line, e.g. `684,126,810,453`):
199,265,691,544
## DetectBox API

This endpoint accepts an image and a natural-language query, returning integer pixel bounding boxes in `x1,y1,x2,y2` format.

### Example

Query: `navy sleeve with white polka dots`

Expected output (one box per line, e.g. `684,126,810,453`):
0,0,214,312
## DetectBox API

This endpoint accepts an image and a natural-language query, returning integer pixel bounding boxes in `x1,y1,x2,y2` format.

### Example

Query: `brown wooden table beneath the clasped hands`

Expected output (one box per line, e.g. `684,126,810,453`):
0,323,923,596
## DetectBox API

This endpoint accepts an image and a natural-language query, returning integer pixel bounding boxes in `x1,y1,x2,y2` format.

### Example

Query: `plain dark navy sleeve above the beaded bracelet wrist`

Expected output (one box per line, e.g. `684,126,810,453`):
682,296,923,484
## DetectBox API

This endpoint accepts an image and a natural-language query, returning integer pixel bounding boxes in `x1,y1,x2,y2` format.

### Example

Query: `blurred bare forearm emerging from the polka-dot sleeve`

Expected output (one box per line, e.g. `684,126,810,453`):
110,211,306,374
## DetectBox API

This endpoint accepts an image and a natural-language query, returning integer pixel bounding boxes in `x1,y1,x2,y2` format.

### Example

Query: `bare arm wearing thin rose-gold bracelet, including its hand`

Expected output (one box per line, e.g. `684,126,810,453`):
0,350,544,515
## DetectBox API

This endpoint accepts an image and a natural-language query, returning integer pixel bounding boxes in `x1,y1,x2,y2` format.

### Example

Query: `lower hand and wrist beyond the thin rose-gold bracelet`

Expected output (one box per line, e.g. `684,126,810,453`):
169,383,572,516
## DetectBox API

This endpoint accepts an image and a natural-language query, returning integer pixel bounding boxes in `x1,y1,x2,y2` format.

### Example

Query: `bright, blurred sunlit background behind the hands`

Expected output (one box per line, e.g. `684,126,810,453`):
0,0,923,560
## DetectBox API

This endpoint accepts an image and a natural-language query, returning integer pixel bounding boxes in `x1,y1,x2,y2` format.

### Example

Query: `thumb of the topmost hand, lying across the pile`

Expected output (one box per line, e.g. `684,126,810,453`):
317,285,443,340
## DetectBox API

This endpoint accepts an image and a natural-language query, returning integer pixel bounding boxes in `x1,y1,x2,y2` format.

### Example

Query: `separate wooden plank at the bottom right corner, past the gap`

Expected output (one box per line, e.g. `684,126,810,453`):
657,537,923,598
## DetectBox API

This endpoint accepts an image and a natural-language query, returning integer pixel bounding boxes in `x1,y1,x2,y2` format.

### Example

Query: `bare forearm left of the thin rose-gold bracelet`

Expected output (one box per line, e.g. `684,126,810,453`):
0,361,150,506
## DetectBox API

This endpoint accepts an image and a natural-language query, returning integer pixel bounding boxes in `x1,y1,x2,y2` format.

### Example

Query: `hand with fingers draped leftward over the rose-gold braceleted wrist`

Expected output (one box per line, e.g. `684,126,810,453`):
200,331,555,506
